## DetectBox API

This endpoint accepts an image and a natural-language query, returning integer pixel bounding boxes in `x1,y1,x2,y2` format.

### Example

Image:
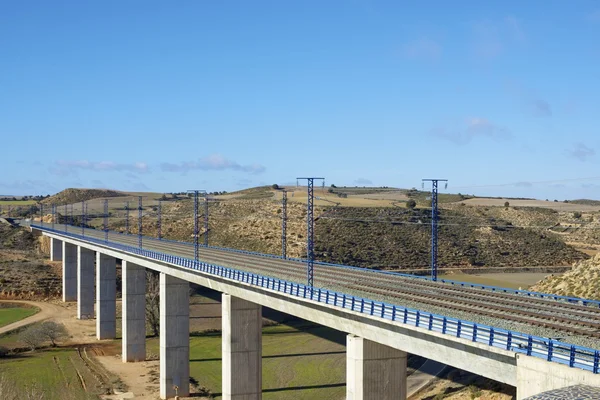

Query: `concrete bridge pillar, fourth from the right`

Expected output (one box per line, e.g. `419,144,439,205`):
121,261,146,362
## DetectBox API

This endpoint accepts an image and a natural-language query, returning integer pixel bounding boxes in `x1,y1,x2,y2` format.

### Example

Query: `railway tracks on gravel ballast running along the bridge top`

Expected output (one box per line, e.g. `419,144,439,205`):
43,222,600,339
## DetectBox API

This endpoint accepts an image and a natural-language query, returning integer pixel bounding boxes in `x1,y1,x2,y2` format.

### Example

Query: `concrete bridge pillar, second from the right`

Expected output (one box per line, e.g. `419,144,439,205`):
222,293,262,400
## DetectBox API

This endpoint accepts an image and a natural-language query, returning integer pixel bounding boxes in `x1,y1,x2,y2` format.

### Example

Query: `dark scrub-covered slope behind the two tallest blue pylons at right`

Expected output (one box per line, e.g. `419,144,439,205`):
315,208,587,268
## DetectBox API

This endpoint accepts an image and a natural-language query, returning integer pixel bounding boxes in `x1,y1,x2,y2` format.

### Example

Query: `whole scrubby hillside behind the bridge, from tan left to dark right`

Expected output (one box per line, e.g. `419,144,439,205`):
99,199,588,269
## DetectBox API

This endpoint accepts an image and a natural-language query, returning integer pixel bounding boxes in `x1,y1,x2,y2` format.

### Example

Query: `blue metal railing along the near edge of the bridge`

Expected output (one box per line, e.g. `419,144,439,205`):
32,224,600,374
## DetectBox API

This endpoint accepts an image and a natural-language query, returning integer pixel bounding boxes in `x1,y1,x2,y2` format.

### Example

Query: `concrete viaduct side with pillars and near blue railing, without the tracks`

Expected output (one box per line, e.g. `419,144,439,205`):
32,224,600,399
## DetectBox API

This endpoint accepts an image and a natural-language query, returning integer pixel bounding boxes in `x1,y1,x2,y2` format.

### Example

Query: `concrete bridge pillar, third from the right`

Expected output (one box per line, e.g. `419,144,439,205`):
160,272,190,399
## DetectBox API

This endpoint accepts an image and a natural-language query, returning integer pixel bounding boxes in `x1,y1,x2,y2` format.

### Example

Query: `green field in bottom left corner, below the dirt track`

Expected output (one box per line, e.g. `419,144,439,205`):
0,348,98,400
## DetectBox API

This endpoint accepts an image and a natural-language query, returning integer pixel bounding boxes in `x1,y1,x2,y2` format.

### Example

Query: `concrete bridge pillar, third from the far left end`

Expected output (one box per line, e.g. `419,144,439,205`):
77,246,95,319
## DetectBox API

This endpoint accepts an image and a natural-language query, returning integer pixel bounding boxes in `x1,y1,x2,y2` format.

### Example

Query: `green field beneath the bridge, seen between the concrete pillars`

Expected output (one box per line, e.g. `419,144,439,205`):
148,322,346,400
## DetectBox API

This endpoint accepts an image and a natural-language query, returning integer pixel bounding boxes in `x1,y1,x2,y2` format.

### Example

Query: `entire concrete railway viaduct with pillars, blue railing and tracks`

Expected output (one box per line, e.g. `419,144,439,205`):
31,222,600,400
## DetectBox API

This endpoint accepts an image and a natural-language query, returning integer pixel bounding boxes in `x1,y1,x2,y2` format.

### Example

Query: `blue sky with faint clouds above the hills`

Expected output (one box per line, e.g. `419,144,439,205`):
0,0,600,199
